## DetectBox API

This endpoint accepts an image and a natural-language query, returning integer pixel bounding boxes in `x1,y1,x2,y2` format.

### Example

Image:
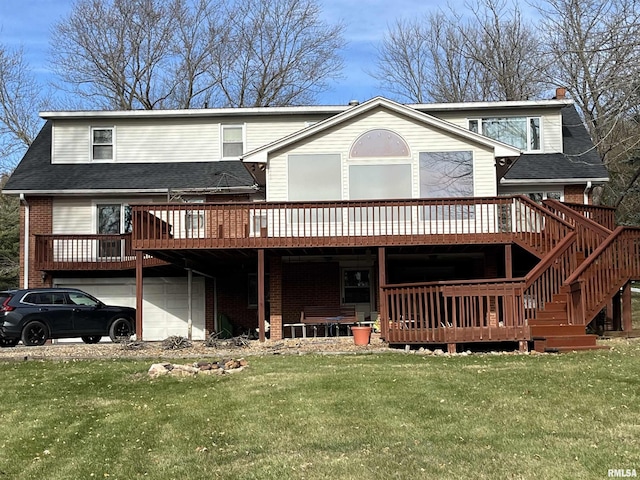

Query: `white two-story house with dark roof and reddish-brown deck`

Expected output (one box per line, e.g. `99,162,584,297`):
5,91,629,349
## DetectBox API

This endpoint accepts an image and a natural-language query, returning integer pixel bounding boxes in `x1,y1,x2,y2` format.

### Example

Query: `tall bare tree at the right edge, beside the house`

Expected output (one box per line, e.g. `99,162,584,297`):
538,0,640,223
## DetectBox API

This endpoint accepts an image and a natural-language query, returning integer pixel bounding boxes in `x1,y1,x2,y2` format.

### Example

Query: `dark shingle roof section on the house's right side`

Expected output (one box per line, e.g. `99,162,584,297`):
504,105,609,180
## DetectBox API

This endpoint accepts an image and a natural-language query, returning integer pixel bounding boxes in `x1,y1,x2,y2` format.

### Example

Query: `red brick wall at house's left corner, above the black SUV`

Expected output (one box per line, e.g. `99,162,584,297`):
20,197,53,287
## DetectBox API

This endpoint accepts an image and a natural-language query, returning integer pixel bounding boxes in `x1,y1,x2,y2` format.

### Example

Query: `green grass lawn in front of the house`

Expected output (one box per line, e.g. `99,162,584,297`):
0,340,640,480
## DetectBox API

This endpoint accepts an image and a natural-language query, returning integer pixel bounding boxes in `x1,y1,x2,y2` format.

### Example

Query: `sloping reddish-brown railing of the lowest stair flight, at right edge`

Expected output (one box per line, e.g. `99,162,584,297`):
565,227,640,324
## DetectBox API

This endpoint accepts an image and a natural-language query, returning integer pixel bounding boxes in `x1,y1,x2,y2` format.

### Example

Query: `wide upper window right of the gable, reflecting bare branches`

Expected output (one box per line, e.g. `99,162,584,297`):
469,117,542,152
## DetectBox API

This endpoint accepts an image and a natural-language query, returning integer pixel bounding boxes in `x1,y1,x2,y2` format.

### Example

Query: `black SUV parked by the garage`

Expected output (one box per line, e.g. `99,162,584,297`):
0,288,136,347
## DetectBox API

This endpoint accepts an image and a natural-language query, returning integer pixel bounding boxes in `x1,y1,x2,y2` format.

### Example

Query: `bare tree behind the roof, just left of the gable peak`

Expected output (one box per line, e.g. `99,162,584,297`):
212,0,343,107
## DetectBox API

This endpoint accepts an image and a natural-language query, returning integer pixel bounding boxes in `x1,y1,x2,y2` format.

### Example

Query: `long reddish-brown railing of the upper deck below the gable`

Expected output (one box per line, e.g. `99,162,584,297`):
132,196,572,255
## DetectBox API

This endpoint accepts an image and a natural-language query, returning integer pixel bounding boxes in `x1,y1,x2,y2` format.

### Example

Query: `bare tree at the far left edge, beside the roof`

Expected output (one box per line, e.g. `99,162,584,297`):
0,44,42,174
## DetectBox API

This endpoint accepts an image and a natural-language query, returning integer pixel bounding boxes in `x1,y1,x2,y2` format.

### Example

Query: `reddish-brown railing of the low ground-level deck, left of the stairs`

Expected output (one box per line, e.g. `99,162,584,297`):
381,278,529,343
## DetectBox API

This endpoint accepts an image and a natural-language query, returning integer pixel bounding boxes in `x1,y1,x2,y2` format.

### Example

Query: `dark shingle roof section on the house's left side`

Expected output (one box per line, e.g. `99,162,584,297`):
4,121,255,192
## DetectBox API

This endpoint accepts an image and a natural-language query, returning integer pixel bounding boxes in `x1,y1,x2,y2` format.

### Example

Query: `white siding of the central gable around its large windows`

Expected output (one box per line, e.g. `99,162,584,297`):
267,108,497,201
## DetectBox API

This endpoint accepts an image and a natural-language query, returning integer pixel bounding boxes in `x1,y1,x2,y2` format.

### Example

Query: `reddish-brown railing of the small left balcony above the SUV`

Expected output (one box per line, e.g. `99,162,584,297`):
35,233,165,271
